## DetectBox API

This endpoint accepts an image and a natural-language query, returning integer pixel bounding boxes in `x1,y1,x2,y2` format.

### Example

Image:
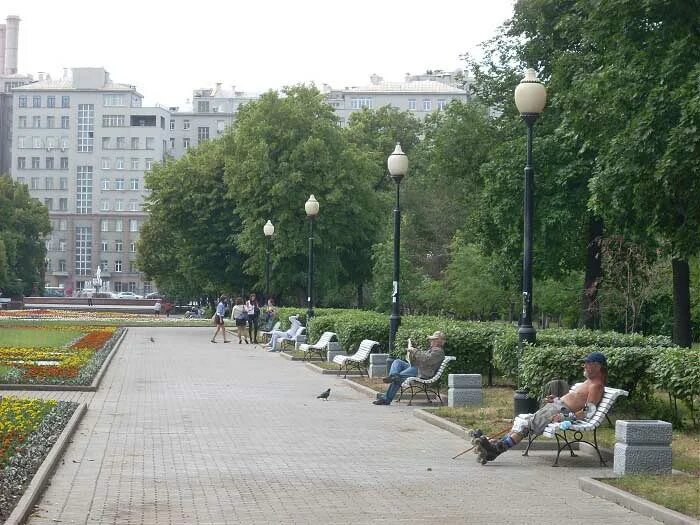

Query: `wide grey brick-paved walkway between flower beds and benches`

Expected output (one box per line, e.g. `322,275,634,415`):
1,328,656,525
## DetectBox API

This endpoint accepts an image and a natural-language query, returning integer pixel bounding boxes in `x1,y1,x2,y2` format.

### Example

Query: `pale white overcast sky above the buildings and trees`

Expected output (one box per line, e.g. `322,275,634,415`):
0,0,513,106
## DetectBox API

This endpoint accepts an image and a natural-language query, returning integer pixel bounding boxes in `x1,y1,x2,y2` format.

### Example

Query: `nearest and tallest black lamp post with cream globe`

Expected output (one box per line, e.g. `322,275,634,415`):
514,69,547,414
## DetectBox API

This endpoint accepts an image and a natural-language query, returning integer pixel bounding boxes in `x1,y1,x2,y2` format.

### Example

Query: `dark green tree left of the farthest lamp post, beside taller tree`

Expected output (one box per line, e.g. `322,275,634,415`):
137,139,246,297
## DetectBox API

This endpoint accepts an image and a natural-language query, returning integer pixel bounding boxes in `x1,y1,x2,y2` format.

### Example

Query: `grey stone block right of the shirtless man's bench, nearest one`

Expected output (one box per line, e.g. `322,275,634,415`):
613,420,673,475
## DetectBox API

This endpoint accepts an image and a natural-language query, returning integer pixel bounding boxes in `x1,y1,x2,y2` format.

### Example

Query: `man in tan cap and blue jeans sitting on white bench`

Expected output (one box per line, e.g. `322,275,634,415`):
372,332,445,405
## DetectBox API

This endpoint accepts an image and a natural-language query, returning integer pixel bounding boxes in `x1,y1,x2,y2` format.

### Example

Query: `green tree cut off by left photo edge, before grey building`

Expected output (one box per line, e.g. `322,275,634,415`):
0,175,51,295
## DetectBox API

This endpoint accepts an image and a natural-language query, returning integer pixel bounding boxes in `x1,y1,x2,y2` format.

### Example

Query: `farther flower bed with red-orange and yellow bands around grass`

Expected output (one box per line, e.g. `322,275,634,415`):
0,326,123,385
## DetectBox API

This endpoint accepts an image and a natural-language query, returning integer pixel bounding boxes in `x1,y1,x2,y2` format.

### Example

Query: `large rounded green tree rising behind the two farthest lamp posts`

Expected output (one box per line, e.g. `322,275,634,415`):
225,85,380,304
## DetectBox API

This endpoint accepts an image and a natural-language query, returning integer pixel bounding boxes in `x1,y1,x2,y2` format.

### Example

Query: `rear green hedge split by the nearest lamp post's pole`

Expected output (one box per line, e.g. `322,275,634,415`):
493,327,673,380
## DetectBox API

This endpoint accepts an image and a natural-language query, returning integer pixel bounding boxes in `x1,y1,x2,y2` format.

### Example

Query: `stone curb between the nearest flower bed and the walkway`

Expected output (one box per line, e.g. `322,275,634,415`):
5,403,87,525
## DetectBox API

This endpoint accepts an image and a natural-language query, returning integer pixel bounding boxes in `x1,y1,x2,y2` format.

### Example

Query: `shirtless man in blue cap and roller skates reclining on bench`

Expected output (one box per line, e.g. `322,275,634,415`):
473,352,608,464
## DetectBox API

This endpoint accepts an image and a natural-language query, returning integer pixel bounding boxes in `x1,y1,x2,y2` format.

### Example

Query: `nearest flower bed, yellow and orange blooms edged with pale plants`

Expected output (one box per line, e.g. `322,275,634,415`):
0,397,78,522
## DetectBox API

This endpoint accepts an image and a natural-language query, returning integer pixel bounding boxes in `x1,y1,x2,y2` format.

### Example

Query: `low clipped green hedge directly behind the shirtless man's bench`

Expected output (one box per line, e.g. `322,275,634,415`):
520,346,671,397
